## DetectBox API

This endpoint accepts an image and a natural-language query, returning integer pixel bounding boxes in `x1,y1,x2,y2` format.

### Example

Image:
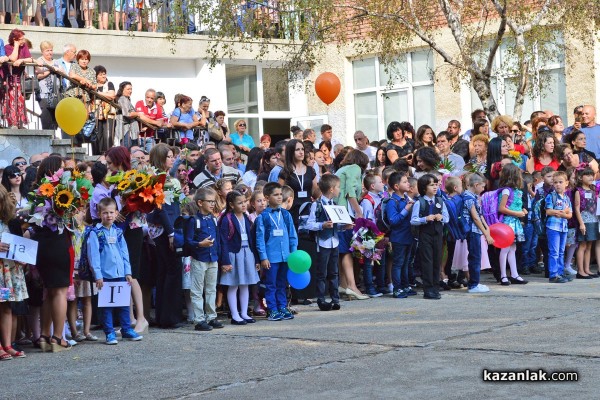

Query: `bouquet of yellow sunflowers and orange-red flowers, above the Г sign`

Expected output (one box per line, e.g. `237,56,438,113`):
106,169,167,214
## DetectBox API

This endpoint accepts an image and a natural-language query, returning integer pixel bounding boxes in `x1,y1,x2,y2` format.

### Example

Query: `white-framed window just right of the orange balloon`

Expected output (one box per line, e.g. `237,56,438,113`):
352,50,435,140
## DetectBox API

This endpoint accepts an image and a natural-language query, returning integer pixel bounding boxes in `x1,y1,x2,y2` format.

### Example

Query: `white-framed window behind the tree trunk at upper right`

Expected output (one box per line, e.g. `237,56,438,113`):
469,35,568,121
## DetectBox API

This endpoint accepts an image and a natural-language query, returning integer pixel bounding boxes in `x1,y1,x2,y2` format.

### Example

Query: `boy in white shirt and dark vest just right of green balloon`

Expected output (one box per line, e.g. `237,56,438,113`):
307,174,340,311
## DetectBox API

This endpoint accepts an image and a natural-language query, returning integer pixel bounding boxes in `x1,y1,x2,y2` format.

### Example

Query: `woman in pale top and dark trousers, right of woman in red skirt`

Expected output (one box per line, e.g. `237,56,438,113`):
35,40,61,130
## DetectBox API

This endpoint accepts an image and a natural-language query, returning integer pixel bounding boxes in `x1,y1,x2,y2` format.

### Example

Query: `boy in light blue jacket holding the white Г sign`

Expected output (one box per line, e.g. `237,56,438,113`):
87,197,143,345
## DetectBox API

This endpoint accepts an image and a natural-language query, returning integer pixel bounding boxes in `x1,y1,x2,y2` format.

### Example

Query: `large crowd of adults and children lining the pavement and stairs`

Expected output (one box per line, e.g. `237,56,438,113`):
0,29,600,360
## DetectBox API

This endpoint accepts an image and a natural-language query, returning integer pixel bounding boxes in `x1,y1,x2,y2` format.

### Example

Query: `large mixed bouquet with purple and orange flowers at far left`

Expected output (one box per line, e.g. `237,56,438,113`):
27,168,90,233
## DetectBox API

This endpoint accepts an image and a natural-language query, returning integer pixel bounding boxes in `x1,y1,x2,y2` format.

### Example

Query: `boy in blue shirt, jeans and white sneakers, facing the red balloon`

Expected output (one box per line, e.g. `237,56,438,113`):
462,173,494,293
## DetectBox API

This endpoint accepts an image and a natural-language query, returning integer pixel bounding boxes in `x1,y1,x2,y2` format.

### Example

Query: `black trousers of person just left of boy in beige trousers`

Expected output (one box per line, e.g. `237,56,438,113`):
154,233,183,328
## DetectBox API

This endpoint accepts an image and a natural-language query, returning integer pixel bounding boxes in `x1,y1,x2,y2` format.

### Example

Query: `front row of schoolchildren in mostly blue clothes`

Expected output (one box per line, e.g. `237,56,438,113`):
67,158,598,344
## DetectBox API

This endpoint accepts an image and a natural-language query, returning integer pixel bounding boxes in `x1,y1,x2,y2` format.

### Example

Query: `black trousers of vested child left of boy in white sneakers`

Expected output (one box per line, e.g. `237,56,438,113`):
418,232,443,293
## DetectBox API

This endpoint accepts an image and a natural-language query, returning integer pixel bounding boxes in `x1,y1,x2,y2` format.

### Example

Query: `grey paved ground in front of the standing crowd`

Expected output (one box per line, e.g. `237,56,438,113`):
5,275,600,400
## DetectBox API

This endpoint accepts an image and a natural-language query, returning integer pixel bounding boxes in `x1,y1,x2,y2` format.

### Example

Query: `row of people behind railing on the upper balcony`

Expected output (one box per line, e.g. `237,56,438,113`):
0,0,284,37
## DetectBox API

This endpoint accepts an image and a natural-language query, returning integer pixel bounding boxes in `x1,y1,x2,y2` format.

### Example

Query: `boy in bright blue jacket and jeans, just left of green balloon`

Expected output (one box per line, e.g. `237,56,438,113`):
254,182,298,321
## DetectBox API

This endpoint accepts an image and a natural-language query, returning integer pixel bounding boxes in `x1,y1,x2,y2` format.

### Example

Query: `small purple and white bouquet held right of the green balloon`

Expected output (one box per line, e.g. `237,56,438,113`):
350,218,389,264
